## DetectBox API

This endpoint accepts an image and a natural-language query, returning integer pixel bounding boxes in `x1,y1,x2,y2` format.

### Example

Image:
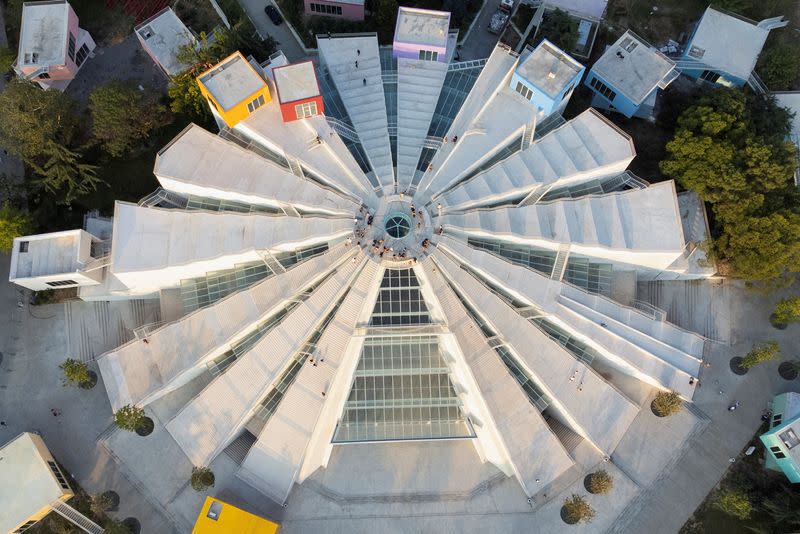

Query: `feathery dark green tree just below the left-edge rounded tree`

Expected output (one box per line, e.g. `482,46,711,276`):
32,141,104,204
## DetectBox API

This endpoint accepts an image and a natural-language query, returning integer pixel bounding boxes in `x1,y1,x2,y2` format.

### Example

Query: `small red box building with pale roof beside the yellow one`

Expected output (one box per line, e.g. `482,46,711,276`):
272,61,325,122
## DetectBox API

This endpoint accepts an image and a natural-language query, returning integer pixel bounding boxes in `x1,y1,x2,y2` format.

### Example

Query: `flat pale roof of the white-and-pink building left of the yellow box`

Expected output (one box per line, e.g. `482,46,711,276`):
134,7,195,76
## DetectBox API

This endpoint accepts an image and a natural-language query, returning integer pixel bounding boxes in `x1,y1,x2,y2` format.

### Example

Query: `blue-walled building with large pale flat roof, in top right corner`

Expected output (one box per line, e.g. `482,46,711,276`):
680,7,789,87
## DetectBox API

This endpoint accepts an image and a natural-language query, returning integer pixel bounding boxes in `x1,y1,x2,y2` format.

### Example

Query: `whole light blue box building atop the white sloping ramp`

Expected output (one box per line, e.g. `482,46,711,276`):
511,39,585,119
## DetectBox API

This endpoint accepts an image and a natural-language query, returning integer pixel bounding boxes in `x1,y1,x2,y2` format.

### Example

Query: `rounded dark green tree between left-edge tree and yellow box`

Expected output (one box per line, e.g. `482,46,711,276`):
89,80,169,156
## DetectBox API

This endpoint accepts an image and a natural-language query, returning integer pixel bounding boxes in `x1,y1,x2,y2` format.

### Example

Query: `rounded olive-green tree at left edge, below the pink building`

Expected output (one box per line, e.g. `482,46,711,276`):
0,78,81,165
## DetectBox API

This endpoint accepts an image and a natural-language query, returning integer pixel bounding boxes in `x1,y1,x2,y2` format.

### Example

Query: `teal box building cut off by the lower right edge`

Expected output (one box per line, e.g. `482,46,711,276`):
760,391,800,484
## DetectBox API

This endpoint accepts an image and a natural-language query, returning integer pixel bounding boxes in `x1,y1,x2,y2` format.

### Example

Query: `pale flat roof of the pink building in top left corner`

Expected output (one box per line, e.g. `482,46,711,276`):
17,0,72,67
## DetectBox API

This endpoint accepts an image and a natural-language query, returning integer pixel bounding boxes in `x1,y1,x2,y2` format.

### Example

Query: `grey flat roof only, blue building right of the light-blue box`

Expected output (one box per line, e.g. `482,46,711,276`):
592,30,677,104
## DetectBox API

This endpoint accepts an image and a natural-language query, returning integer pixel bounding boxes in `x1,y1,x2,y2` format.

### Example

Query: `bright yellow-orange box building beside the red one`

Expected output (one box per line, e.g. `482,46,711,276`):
197,52,271,128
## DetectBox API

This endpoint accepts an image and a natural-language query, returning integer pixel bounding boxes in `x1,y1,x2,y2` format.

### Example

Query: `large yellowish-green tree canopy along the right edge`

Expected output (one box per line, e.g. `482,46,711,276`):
661,89,800,286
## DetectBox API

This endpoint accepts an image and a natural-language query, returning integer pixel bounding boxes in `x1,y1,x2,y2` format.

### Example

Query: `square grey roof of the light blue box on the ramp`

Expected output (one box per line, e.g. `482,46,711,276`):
517,39,583,97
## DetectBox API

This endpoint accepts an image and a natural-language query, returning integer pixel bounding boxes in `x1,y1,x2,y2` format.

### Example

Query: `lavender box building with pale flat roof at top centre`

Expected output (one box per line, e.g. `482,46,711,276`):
392,7,450,62
